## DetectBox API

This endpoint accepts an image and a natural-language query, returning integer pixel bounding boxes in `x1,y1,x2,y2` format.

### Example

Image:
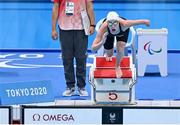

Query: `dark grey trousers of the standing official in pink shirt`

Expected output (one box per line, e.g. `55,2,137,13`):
60,29,88,88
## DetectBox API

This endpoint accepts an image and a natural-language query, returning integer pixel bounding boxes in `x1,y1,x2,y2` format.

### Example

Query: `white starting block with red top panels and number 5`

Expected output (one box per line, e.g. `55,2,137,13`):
89,56,136,104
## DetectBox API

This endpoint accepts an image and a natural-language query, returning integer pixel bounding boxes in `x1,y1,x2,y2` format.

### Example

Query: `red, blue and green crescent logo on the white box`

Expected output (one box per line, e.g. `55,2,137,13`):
144,41,162,55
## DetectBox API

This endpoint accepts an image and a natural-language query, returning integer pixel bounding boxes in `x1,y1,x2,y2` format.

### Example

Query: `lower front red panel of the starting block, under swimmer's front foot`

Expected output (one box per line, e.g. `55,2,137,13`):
94,68,132,78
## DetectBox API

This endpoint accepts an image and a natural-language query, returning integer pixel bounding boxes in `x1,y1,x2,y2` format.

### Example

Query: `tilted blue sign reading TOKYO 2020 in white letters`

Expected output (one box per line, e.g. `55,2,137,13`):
0,81,54,105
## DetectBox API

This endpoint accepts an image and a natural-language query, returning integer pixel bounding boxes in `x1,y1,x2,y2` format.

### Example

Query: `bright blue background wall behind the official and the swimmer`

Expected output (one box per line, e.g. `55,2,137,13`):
0,3,180,50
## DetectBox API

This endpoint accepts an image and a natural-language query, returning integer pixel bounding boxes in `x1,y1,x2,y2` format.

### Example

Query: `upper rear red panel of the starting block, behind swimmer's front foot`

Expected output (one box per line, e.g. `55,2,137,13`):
96,57,130,68
